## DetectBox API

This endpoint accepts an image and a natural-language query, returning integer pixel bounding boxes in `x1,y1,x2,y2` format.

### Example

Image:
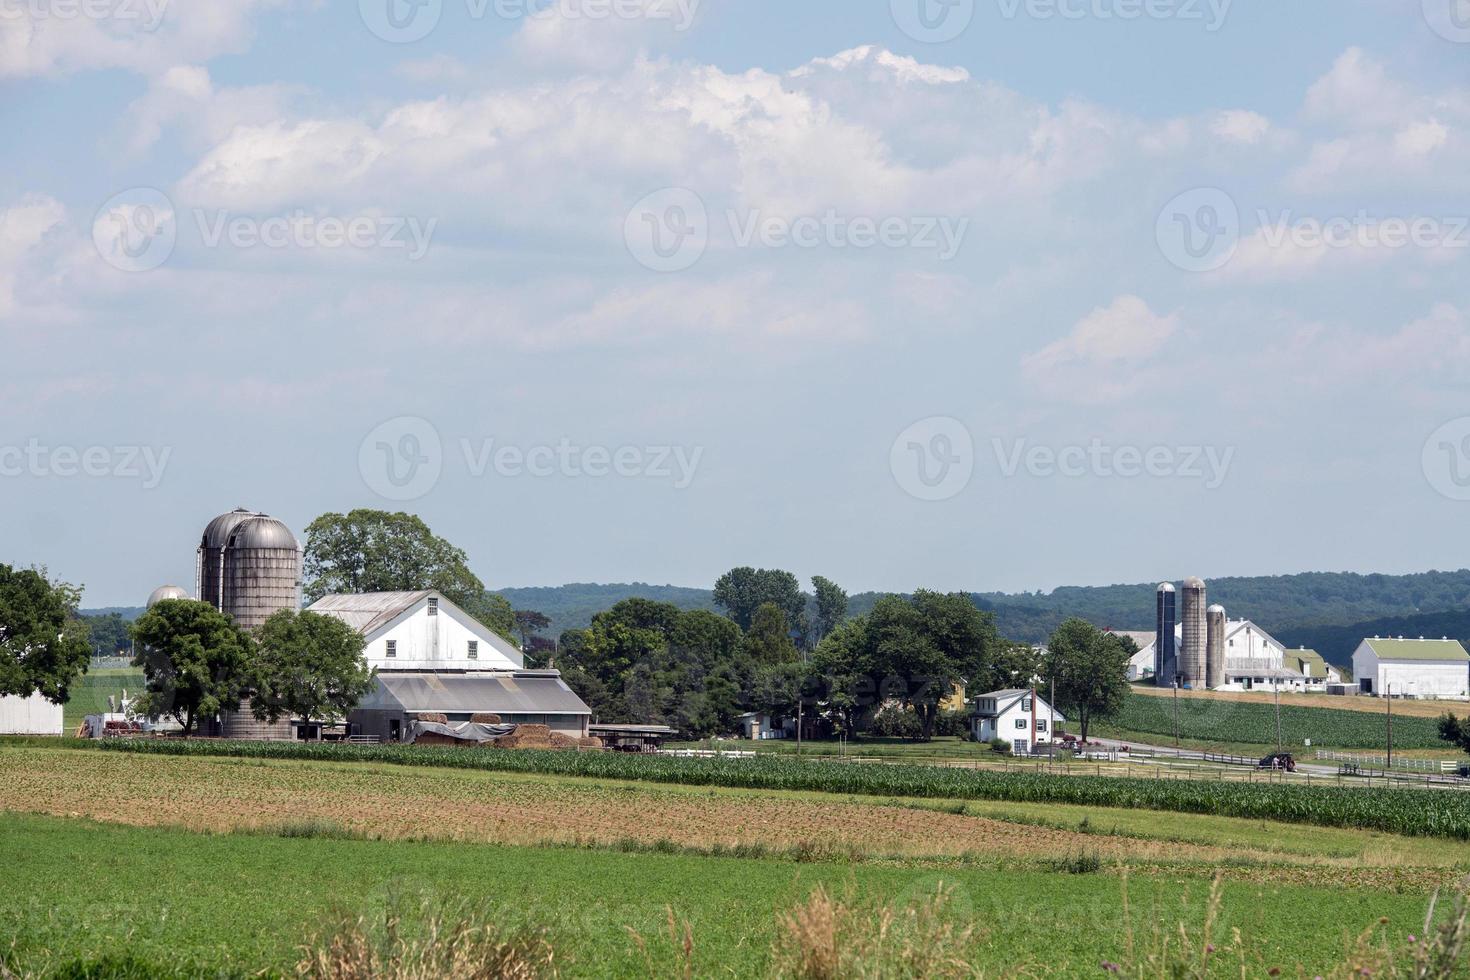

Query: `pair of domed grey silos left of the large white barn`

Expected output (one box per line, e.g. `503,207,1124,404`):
196,507,301,739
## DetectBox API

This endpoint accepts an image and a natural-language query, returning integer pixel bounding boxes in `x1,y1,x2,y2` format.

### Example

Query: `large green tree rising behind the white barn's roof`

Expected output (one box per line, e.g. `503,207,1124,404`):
304,510,516,642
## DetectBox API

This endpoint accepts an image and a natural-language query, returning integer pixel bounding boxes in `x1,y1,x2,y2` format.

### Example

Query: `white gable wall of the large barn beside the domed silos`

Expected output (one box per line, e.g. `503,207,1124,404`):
363,598,525,670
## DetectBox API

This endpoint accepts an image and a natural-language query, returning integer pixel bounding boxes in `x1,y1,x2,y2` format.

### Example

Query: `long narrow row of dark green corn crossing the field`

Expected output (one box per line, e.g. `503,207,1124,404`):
71,739,1470,840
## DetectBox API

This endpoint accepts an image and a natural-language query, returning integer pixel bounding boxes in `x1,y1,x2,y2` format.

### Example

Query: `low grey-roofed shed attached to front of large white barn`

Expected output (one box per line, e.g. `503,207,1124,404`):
347,670,592,742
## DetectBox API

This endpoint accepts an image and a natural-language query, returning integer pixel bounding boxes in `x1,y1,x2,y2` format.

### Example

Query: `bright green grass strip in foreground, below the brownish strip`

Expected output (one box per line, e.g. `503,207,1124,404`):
0,814,1446,977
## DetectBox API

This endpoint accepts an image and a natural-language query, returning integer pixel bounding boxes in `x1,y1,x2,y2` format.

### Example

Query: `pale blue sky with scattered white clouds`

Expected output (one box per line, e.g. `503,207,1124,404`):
0,0,1470,605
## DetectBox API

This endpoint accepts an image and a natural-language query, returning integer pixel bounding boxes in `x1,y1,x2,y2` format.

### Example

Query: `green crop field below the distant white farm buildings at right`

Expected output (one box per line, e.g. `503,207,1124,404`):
1107,692,1448,751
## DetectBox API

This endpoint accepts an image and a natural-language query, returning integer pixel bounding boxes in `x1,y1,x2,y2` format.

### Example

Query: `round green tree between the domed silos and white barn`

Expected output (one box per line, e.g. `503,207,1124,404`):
250,610,373,723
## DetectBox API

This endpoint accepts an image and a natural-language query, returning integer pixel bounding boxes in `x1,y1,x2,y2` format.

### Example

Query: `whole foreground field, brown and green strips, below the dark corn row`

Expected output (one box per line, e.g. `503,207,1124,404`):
0,746,1470,977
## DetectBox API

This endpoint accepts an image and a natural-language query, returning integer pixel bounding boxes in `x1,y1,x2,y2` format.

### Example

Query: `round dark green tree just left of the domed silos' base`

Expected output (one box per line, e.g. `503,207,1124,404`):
132,599,254,736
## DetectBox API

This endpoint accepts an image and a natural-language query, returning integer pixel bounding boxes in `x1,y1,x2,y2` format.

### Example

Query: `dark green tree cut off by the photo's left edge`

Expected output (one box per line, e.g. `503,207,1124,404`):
0,564,91,704
